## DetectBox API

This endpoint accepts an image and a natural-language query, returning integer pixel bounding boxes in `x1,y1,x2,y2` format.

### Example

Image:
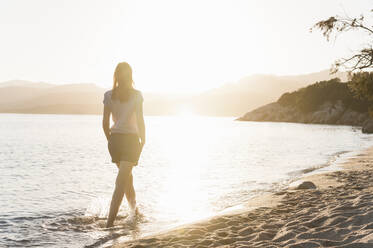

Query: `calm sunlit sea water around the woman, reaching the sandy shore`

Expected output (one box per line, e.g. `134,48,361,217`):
0,114,373,247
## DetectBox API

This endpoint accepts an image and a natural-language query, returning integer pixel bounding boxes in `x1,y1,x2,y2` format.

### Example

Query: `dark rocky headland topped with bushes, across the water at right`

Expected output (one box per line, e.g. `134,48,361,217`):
237,78,372,131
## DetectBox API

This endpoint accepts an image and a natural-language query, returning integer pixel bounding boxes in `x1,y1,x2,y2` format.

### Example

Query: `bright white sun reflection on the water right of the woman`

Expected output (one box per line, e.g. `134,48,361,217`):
156,113,212,223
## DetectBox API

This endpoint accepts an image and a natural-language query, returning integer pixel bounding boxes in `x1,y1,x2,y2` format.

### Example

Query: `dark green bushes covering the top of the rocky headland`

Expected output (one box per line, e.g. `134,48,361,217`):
277,78,369,113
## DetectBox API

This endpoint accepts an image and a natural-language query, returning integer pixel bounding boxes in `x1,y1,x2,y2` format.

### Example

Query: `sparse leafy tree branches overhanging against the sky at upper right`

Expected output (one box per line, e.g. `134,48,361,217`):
311,9,373,74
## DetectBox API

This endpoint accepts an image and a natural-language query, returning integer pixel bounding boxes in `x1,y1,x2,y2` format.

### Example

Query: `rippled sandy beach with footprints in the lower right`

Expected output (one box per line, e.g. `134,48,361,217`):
113,147,373,248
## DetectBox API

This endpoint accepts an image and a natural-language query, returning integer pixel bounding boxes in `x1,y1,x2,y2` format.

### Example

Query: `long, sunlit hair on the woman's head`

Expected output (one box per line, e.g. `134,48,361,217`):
111,62,135,102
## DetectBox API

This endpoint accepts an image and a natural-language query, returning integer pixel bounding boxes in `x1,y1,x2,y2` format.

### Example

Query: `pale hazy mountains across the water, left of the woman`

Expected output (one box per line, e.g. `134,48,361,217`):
0,81,105,114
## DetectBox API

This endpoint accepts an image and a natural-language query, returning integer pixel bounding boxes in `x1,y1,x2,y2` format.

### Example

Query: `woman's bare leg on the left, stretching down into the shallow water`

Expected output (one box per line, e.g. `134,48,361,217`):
106,161,133,227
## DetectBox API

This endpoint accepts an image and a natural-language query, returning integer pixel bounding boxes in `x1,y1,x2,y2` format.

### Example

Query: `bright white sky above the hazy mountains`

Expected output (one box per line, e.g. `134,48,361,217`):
0,0,373,92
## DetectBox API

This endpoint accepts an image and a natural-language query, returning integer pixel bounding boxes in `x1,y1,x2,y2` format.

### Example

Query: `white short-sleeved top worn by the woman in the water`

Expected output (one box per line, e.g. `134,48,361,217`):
102,90,144,134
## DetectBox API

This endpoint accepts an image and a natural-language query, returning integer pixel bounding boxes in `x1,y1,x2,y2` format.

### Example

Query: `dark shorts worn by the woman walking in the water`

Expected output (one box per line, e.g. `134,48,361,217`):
108,133,142,165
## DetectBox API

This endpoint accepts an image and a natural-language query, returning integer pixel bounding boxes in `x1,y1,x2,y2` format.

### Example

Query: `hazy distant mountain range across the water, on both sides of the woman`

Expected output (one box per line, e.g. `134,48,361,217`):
0,71,345,116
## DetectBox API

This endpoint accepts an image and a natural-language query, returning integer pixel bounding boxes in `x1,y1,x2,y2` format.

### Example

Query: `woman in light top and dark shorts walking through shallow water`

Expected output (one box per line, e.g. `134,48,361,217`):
102,62,145,227
